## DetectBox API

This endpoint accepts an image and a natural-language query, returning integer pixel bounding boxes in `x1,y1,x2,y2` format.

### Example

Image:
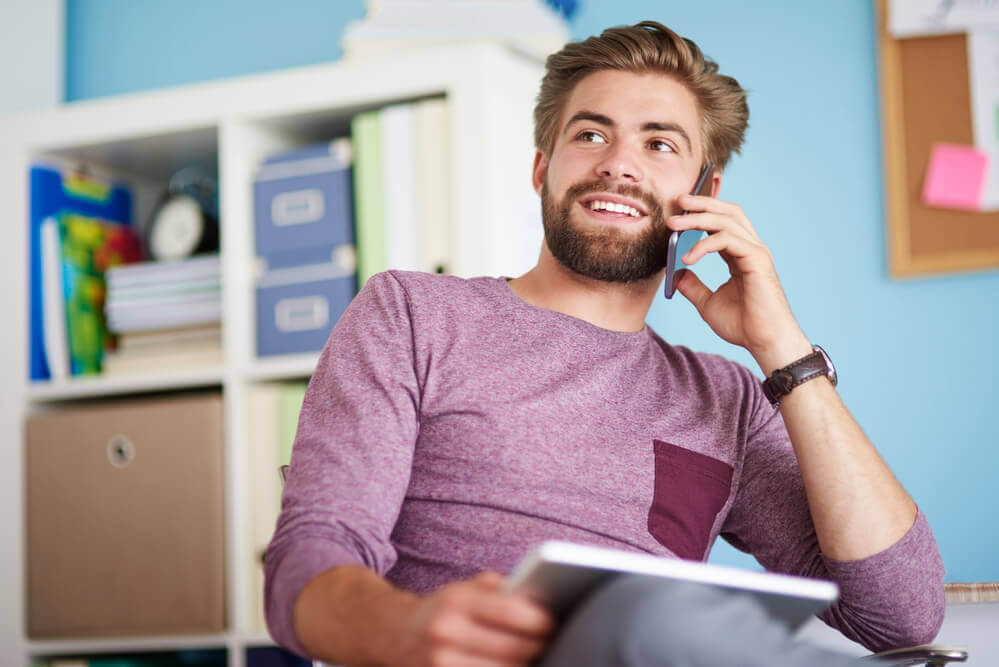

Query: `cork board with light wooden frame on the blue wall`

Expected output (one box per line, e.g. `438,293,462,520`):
875,0,999,277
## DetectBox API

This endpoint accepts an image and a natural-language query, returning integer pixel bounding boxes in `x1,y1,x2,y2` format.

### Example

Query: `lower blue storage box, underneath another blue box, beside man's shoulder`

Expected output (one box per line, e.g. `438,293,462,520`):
257,258,357,357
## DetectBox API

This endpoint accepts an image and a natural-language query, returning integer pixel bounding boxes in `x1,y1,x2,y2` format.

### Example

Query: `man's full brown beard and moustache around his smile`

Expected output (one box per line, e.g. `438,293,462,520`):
541,181,670,283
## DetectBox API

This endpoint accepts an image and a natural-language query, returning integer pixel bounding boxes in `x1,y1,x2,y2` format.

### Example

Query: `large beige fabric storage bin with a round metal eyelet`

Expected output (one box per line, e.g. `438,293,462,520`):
26,393,225,638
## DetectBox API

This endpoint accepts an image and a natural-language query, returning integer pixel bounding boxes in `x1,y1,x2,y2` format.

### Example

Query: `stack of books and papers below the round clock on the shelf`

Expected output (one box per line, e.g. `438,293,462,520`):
102,255,222,374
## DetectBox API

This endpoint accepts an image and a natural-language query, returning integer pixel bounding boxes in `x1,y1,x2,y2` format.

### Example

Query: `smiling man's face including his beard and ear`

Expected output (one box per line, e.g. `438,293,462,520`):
534,70,717,282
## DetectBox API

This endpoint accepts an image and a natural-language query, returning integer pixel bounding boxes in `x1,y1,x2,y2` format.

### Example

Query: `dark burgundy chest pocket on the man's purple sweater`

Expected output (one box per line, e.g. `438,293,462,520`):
649,440,732,561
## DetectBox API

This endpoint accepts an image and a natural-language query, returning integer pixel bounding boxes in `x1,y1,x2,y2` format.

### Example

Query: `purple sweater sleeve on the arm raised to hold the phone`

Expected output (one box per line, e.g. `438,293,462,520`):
722,383,945,652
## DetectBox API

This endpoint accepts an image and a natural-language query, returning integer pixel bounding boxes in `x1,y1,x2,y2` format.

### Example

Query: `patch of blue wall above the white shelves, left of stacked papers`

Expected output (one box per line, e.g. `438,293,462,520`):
66,0,364,101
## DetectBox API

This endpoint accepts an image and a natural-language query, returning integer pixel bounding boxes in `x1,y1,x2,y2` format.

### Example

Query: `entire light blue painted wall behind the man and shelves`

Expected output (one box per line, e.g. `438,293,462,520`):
66,0,999,581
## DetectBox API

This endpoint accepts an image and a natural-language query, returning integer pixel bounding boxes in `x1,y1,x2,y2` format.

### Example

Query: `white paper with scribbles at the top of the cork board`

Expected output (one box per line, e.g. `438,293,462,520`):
888,0,999,38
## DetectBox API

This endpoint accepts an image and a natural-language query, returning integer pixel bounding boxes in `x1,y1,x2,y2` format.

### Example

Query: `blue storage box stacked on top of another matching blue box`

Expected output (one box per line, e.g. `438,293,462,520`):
253,139,354,257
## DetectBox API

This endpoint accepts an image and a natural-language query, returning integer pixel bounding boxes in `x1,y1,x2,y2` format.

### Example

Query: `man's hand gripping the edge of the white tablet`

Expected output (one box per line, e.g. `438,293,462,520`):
395,572,555,667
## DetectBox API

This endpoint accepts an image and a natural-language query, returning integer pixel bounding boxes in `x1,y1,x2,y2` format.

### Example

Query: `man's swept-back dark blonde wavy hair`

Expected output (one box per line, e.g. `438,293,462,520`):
534,21,749,169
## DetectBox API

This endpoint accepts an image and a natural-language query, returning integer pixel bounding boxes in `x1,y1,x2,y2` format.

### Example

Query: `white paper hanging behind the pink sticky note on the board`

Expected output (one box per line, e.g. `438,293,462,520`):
968,30,999,211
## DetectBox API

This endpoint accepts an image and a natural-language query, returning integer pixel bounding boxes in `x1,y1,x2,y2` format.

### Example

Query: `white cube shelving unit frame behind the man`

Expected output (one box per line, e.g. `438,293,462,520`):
0,44,542,667
